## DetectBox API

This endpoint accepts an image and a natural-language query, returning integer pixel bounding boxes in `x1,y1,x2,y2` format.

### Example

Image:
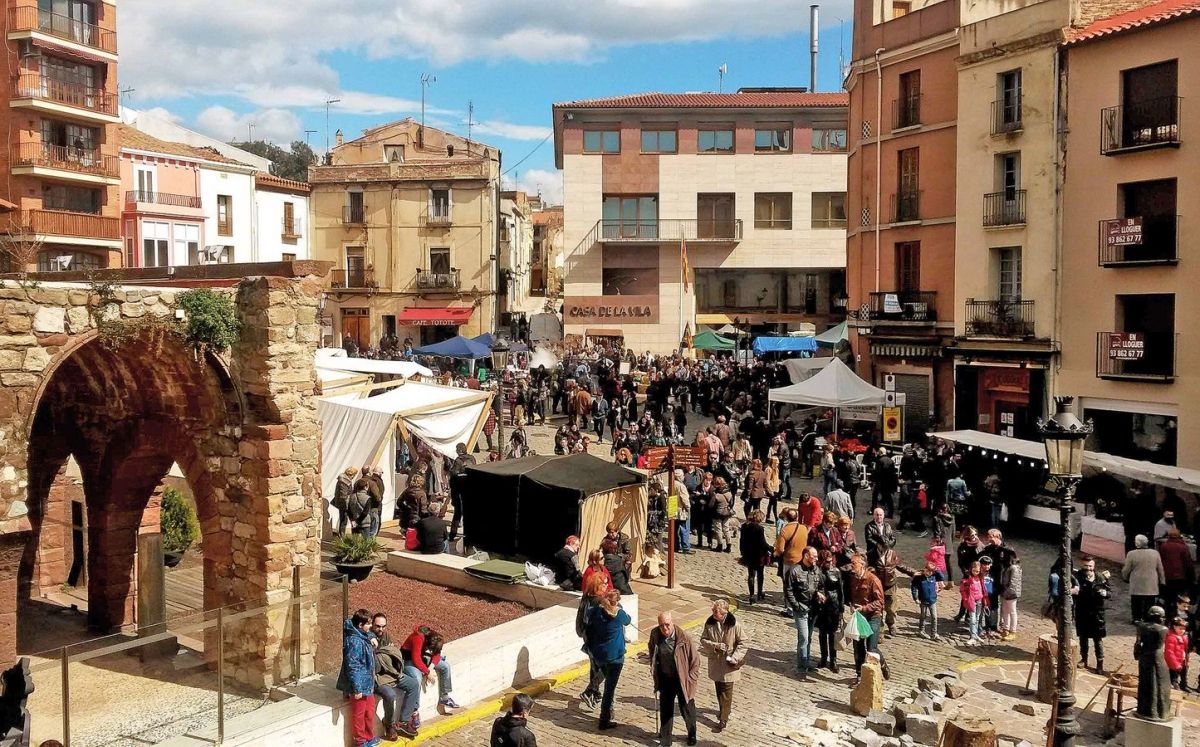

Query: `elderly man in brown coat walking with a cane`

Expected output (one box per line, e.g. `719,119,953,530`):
646,612,700,745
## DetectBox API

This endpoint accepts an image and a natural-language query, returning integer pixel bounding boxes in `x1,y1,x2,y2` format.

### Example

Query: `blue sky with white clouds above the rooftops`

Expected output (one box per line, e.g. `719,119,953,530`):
118,0,851,203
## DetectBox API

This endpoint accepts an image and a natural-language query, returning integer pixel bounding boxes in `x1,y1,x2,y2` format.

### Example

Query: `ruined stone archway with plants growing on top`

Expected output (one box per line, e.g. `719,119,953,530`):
0,262,328,688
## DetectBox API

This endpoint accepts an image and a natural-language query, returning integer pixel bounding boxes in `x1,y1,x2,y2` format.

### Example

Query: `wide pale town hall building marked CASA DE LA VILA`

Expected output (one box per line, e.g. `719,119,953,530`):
553,89,846,353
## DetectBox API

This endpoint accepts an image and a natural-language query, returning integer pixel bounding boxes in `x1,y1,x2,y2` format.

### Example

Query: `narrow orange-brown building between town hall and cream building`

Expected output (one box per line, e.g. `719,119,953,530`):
846,0,959,437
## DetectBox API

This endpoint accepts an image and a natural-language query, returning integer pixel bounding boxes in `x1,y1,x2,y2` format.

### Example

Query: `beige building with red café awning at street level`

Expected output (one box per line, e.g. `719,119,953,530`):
310,119,500,347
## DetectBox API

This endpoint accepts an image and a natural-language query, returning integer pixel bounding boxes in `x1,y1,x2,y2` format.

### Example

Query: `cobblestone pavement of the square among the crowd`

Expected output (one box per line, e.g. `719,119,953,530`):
436,422,1198,747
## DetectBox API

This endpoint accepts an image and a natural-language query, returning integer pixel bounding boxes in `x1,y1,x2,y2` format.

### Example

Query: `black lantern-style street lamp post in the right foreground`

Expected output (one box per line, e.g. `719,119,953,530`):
1038,396,1092,747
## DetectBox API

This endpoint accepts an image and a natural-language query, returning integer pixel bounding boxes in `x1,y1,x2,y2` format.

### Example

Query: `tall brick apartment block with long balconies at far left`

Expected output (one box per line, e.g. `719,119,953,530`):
0,0,121,270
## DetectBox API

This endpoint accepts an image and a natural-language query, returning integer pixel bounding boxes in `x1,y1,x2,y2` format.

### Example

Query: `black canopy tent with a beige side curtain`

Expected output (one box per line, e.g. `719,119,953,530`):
463,454,648,571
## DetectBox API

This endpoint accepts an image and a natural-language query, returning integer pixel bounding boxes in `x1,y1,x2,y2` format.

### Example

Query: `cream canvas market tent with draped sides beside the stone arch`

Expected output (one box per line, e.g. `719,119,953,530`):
317,381,492,533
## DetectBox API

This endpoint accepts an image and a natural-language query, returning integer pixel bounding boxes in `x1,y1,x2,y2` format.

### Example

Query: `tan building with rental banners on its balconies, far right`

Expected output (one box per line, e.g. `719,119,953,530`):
1058,0,1200,468
